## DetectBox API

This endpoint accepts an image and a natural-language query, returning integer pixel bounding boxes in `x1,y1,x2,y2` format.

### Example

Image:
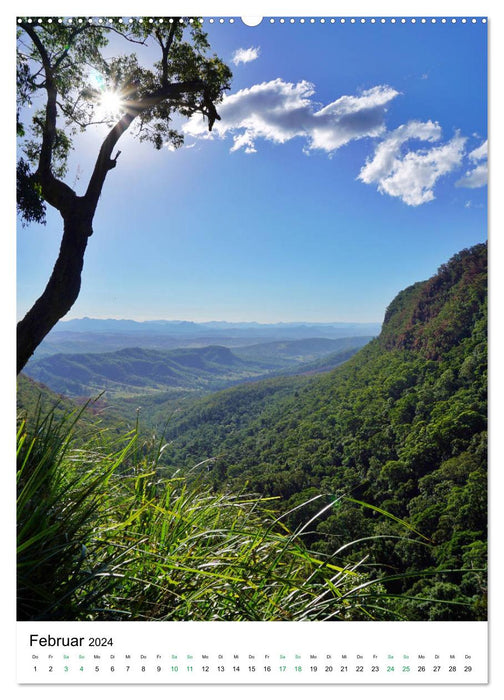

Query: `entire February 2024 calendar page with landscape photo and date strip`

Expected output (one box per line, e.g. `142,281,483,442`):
14,1,488,692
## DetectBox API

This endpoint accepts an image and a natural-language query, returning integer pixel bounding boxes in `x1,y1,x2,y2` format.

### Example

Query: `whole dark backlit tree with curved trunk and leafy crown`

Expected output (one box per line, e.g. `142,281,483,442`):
17,17,231,373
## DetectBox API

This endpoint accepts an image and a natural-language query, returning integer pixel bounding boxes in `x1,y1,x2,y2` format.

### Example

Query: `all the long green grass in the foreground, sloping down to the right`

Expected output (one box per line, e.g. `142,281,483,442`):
17,407,402,620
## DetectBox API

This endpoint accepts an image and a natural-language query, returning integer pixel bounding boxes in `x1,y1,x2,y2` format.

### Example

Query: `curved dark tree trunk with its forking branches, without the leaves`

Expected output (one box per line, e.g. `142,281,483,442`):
17,22,221,374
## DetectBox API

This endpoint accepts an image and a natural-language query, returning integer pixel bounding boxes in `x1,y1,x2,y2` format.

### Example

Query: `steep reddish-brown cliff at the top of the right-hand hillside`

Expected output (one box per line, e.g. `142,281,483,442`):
380,243,487,360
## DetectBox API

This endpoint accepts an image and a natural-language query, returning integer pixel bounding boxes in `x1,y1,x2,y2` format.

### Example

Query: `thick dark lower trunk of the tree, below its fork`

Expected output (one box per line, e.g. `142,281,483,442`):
17,205,93,374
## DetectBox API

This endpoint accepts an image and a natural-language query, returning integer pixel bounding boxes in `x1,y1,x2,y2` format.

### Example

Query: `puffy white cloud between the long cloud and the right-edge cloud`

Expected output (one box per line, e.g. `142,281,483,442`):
358,121,466,206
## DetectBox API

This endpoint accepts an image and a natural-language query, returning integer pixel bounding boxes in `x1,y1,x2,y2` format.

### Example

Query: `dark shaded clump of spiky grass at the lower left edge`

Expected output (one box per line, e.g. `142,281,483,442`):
17,400,123,620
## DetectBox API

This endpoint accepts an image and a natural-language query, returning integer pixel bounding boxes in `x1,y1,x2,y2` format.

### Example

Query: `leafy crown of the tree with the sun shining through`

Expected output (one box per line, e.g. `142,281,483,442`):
17,17,231,223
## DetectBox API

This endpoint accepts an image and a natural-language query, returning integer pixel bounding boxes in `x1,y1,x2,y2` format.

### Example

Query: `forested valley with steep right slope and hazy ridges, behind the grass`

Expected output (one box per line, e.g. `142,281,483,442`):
18,244,487,620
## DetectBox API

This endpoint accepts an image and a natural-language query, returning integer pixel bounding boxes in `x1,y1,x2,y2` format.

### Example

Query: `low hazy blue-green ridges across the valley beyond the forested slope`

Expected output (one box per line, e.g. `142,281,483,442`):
25,336,370,403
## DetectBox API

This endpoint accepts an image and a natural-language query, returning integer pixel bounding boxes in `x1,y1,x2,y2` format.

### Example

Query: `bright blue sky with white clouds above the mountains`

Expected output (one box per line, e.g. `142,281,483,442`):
17,13,487,322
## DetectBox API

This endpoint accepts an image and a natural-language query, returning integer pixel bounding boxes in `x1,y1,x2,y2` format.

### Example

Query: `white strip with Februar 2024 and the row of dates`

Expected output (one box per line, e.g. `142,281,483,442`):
18,622,487,684
